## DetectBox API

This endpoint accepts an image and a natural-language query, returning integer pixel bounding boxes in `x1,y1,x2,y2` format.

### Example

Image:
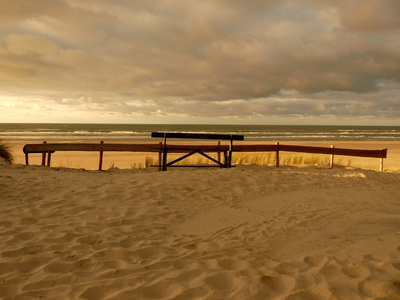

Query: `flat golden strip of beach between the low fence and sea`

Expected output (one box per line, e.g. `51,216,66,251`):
4,140,400,171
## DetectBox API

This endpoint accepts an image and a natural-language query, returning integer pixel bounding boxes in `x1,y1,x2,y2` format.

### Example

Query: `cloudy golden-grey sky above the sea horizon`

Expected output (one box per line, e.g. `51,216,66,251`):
0,0,400,125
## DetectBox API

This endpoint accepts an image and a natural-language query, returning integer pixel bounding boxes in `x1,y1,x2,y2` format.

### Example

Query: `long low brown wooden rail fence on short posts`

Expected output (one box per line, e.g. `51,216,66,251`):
23,142,387,171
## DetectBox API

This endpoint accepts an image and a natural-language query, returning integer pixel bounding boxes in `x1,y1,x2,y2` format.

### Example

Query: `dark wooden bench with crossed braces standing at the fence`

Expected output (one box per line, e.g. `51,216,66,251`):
151,132,244,171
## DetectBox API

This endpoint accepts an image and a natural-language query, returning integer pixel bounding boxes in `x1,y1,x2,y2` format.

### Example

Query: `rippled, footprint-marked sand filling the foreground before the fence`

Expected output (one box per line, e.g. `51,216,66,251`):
0,142,400,299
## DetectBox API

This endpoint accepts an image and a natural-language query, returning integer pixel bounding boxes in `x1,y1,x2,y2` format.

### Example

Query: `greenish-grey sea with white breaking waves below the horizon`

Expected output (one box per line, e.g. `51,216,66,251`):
0,123,400,142
